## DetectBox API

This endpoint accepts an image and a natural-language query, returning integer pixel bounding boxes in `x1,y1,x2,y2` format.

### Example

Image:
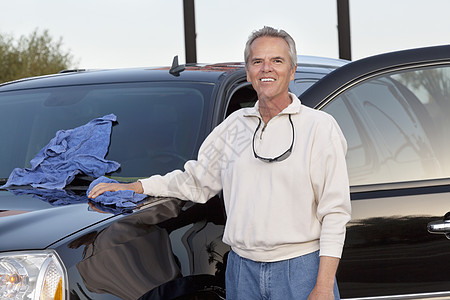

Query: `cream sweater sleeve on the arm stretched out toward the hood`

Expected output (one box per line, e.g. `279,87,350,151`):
139,124,224,203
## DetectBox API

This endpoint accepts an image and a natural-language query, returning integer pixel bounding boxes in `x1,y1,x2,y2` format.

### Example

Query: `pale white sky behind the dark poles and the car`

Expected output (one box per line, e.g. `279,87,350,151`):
0,0,450,69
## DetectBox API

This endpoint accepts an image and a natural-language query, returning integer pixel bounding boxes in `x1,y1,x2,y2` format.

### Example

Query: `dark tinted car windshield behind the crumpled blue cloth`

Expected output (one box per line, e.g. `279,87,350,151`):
0,82,213,178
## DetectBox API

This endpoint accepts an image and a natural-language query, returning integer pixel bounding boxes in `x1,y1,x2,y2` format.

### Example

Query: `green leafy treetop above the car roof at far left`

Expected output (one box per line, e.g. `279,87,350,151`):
0,29,73,83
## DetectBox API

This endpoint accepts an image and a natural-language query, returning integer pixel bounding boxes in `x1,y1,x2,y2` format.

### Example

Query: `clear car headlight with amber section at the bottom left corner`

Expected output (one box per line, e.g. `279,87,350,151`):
0,250,67,300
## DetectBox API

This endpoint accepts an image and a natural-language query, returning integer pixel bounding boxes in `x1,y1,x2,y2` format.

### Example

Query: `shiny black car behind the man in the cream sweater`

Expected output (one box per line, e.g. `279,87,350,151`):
0,45,450,299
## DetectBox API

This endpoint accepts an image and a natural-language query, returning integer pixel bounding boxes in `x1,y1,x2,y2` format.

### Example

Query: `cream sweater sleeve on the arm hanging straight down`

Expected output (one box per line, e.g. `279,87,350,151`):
311,116,351,258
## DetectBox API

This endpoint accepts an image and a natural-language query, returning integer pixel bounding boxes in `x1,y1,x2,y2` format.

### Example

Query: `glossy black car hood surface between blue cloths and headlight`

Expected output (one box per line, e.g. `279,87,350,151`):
0,189,123,251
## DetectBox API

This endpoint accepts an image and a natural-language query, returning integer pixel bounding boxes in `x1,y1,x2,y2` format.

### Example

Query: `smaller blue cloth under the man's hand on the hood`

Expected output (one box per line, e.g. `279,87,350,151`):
86,176,147,208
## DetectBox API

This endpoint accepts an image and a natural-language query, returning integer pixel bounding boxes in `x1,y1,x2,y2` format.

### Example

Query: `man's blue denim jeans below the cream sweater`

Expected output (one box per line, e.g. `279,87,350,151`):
225,251,340,300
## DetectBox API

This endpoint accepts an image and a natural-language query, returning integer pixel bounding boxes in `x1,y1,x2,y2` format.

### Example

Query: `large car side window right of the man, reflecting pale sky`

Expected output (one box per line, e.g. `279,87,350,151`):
324,65,450,185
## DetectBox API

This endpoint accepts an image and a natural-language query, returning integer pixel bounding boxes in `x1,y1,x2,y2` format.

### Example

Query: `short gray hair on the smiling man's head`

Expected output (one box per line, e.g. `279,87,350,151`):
244,26,297,69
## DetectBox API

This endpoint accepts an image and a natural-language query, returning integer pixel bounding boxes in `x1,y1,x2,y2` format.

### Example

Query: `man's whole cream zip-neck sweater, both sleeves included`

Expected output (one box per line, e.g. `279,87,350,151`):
141,94,351,262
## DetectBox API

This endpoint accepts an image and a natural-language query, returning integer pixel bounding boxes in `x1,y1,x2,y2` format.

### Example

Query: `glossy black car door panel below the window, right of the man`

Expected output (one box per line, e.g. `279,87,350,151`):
337,186,450,298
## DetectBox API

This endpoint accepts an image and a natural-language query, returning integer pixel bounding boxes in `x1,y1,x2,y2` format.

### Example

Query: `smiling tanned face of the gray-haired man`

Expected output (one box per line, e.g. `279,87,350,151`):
246,37,295,100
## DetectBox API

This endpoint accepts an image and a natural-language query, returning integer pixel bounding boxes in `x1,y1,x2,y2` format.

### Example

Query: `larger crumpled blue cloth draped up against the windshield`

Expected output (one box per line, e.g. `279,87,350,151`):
2,114,120,189
